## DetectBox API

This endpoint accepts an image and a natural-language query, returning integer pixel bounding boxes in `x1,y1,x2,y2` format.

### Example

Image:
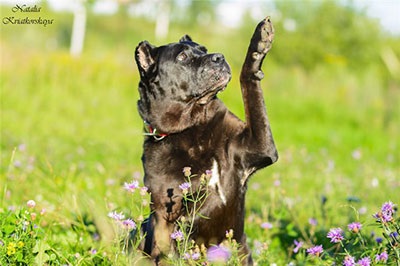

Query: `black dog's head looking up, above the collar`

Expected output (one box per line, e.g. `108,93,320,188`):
135,35,231,133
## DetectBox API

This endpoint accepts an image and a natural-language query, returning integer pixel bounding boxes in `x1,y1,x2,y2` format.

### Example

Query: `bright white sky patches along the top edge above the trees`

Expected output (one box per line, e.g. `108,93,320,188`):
0,0,400,35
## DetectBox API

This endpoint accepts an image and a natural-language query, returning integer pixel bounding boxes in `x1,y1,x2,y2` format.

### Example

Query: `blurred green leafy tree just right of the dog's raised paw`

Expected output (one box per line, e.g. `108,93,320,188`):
275,1,382,69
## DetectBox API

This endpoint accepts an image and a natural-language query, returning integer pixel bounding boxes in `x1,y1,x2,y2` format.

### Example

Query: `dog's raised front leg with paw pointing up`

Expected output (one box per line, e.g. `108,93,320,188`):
240,17,278,170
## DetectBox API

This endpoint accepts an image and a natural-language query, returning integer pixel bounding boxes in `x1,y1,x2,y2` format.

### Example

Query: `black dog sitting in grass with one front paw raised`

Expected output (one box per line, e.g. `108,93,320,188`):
135,18,278,264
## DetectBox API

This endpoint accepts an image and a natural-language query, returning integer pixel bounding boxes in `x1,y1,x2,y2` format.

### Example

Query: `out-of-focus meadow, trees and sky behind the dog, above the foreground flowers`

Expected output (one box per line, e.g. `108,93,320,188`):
0,0,400,258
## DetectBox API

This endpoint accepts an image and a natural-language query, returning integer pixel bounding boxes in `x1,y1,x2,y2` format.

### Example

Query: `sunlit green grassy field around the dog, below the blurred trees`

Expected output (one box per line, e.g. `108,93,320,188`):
0,7,400,265
